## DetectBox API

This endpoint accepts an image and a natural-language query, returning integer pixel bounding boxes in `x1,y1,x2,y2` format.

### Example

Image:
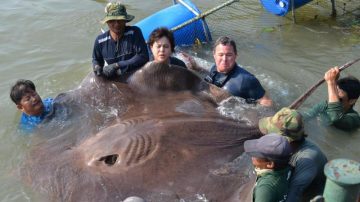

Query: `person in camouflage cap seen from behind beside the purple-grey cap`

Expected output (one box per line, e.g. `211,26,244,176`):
259,108,327,202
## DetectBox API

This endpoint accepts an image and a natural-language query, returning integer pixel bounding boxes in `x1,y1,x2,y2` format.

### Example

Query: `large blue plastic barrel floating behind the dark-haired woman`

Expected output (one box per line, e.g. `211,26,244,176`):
135,0,211,46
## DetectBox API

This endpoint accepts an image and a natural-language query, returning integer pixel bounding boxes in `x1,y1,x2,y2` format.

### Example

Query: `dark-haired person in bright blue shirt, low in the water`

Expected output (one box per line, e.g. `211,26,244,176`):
10,79,53,133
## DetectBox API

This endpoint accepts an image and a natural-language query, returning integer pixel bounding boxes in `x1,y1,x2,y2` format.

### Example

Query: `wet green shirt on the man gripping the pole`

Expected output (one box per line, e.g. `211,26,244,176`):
300,101,360,131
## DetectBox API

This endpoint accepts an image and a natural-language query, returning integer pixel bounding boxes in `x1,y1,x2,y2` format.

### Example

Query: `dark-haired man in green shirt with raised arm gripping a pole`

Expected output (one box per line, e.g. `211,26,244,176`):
301,67,360,131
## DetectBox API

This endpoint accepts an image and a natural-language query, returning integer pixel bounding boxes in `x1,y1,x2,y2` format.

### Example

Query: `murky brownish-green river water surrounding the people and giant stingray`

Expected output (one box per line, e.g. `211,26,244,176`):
0,0,360,202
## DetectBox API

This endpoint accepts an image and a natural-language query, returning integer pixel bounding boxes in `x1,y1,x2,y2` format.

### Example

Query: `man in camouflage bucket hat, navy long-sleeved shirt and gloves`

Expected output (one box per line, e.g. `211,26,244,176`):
92,2,149,78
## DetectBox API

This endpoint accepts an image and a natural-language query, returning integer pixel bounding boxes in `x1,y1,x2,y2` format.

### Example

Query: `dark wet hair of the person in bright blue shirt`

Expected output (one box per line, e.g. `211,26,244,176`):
10,79,36,104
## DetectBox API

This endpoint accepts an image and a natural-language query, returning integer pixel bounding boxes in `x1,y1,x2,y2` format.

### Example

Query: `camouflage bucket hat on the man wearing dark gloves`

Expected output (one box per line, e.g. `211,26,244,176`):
101,2,135,24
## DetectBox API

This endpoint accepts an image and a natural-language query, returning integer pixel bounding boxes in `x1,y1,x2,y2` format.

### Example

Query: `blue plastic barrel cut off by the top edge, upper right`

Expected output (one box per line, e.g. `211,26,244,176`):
260,0,311,16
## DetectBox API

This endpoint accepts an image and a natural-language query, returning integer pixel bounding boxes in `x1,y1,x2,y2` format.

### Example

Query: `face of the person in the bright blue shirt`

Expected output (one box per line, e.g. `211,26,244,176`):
17,90,44,116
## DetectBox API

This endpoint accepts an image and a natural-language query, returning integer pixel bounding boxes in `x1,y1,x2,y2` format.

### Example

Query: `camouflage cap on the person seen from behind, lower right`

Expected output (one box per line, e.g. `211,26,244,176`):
259,107,306,142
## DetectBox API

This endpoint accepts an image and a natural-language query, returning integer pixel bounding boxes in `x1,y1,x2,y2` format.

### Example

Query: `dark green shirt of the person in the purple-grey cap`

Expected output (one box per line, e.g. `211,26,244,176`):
253,166,291,202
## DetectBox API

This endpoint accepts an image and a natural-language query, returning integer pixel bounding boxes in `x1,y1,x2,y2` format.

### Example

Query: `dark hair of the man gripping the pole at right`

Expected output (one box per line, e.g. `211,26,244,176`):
337,76,360,100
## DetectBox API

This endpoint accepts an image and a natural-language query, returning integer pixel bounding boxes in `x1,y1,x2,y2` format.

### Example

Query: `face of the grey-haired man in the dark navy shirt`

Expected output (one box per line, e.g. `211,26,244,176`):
214,44,237,74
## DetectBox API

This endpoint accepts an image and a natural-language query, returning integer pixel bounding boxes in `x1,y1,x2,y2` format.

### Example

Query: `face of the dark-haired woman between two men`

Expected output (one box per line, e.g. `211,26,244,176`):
150,37,172,62
